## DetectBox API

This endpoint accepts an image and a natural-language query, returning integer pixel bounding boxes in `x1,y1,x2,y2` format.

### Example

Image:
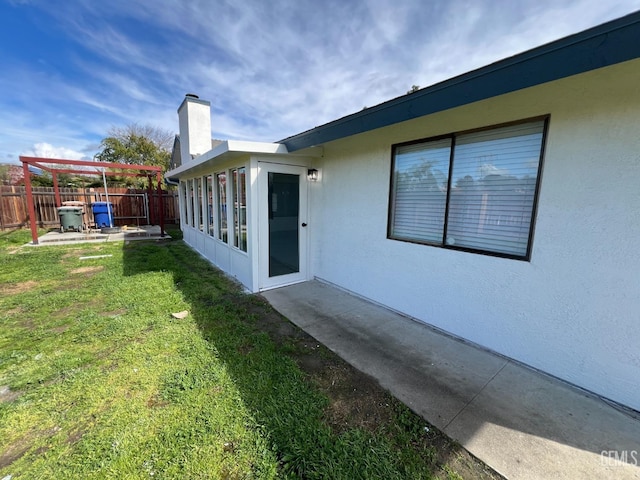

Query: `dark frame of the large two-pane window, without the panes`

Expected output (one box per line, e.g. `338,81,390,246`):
387,115,551,262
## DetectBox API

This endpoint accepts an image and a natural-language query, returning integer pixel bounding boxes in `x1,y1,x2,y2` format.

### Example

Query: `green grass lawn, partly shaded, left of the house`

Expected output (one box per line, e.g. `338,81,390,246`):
0,231,492,480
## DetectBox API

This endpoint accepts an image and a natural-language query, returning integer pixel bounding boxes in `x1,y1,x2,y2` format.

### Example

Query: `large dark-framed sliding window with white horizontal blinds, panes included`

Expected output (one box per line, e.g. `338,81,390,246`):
388,118,547,260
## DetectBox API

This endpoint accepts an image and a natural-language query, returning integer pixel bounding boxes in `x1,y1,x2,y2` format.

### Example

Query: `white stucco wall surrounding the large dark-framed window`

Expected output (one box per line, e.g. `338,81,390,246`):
311,57,640,409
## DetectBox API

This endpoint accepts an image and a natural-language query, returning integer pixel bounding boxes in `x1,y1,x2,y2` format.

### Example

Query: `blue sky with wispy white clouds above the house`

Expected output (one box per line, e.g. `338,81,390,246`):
0,0,640,163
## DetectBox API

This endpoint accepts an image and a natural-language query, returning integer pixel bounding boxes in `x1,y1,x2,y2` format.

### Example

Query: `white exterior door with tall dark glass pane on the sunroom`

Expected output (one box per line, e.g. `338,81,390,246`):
258,162,308,290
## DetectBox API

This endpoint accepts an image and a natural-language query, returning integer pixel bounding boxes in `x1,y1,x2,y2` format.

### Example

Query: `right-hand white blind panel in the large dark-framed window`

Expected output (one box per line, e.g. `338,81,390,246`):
445,121,544,256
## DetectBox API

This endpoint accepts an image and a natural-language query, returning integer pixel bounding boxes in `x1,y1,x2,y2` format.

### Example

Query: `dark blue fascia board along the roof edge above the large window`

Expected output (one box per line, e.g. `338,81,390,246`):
278,11,640,152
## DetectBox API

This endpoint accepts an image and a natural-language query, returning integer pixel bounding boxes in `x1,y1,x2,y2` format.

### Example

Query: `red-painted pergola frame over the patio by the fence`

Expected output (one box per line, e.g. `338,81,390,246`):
20,156,164,245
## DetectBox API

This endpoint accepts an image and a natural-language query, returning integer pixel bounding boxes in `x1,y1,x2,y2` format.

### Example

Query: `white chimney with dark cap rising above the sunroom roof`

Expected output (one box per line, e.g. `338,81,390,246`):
178,93,211,165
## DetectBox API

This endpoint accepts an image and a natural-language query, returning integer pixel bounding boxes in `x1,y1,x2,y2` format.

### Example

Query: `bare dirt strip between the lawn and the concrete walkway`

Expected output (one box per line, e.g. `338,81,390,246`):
238,295,504,479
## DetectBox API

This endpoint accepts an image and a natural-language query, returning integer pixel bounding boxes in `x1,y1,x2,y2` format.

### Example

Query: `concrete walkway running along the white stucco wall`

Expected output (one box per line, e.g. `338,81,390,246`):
263,281,640,479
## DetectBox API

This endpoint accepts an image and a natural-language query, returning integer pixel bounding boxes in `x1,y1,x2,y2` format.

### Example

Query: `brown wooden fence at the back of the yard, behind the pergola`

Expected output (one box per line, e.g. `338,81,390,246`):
0,185,180,230
